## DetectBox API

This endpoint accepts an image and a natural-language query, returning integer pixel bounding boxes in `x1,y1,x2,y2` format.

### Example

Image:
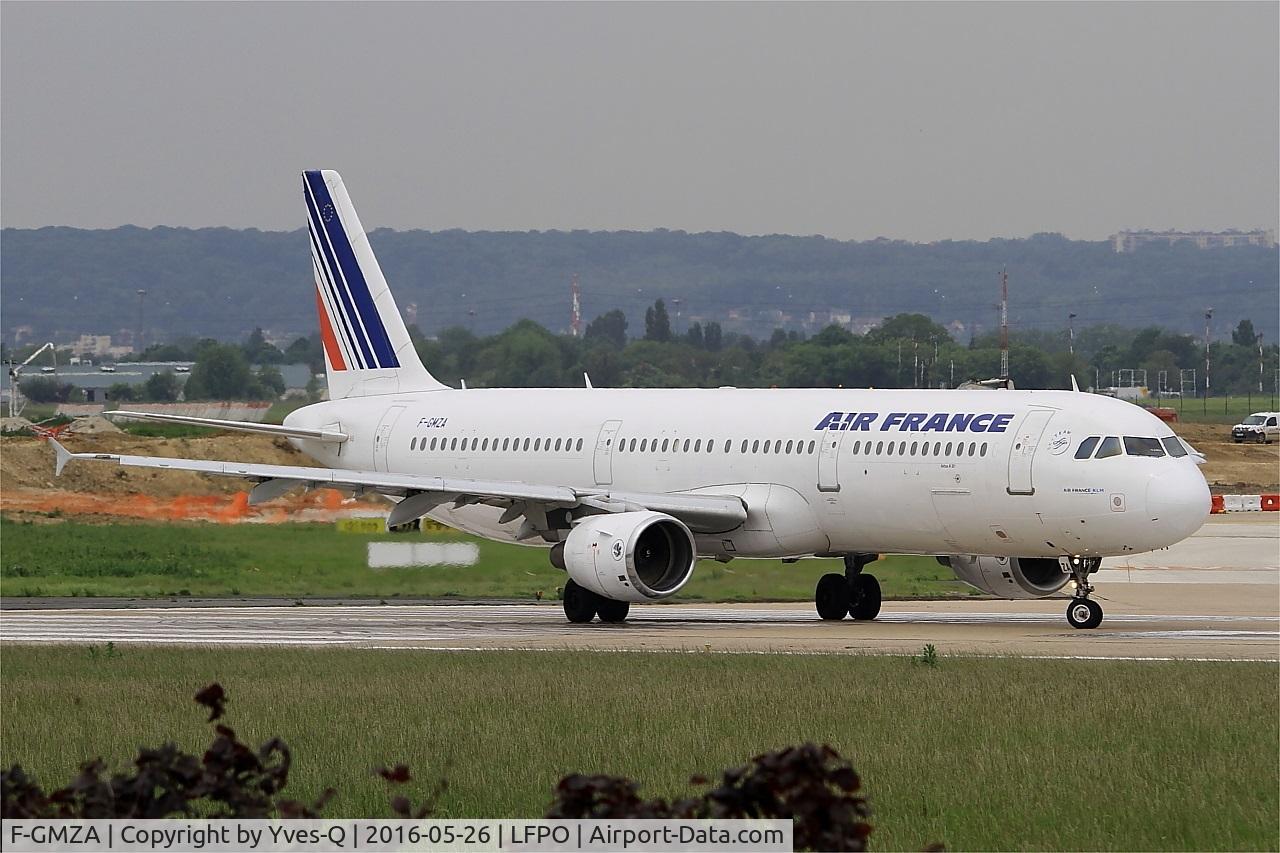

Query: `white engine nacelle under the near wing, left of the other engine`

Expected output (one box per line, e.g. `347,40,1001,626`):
563,512,698,602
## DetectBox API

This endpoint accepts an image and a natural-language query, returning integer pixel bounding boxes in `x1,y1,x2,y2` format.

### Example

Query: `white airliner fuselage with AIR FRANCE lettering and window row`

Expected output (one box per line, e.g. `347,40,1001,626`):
285,388,1210,557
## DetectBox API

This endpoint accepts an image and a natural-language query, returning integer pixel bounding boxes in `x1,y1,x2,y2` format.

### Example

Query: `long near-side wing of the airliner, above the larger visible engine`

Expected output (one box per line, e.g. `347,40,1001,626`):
49,438,746,534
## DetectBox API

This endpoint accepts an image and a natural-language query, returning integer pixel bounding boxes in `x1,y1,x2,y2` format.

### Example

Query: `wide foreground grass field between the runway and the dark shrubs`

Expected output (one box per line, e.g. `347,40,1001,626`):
0,646,1280,849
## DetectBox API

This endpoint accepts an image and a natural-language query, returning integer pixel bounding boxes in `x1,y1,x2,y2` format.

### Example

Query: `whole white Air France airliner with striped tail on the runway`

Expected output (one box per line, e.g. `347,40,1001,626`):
54,170,1210,629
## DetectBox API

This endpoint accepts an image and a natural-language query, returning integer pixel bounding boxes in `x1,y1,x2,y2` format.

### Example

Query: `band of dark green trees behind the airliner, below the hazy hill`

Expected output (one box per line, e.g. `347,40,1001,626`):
10,306,1280,400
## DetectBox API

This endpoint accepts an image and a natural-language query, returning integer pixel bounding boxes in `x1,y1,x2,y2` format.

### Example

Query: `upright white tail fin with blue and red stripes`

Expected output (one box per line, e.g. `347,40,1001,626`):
302,169,444,400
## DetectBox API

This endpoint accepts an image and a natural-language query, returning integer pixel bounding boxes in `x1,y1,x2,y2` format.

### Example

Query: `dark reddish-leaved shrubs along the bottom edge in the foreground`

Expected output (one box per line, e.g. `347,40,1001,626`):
0,683,872,850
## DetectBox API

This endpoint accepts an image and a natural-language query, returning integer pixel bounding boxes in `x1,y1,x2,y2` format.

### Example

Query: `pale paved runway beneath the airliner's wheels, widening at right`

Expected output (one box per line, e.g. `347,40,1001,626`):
0,519,1280,662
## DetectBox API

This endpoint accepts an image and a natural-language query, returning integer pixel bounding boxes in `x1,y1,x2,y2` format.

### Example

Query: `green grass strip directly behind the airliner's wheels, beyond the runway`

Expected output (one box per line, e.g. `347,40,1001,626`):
0,519,968,601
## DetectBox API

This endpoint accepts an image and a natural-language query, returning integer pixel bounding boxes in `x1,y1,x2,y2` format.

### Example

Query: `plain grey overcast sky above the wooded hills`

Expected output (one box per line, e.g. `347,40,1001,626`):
0,3,1280,241
